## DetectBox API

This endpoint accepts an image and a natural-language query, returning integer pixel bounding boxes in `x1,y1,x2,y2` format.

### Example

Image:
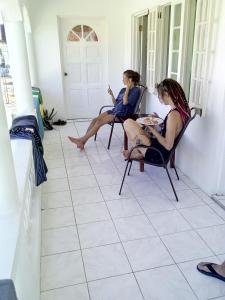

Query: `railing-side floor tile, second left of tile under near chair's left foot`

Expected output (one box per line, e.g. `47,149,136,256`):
42,191,72,209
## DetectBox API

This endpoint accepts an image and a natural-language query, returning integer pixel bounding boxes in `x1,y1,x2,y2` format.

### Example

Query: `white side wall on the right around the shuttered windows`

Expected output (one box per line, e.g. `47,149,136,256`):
126,0,225,194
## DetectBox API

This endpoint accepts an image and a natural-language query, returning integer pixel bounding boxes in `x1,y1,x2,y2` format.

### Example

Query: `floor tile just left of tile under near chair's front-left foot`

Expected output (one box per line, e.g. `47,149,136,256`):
71,187,104,205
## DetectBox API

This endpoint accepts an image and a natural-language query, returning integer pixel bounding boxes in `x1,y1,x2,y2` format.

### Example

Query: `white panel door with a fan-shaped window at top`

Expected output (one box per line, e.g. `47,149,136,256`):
60,18,107,119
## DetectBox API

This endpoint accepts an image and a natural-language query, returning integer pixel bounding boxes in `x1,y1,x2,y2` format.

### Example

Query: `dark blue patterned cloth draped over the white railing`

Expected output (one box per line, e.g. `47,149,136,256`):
9,115,48,186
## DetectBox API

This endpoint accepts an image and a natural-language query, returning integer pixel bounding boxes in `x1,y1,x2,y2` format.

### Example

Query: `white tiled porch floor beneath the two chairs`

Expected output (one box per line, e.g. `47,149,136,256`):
41,122,225,300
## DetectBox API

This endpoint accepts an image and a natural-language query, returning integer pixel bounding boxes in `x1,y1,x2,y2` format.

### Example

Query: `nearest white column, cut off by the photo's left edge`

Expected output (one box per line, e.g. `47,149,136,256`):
0,88,19,216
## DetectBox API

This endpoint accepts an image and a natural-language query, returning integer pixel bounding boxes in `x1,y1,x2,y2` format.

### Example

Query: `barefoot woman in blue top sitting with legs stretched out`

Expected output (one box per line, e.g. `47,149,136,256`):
68,70,140,149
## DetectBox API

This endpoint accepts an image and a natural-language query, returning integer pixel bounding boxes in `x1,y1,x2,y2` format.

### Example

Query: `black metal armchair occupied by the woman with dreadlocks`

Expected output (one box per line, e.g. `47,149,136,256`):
119,107,202,201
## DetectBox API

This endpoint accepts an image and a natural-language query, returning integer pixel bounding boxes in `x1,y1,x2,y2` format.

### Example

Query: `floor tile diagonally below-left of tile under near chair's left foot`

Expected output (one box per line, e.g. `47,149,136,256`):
74,202,110,224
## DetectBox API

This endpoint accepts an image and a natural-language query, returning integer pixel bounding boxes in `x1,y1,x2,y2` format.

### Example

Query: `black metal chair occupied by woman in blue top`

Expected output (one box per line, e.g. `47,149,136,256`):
95,85,147,149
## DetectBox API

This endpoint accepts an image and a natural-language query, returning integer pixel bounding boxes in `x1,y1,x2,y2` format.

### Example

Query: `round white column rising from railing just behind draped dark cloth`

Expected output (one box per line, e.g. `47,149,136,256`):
4,21,34,115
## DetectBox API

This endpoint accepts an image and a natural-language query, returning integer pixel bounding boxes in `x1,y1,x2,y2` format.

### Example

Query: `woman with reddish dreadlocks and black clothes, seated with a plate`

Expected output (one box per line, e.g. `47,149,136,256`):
123,79,191,163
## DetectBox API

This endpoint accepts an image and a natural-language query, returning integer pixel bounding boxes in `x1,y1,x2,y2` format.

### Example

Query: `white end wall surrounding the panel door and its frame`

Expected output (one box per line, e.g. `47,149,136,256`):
29,0,125,117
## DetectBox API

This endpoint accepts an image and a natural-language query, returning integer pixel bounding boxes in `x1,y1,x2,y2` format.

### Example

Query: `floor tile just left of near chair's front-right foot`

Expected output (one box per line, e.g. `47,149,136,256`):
137,194,175,214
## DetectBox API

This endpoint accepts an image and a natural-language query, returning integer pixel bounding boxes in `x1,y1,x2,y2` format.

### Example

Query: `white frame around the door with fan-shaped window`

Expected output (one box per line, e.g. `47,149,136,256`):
56,15,109,119
